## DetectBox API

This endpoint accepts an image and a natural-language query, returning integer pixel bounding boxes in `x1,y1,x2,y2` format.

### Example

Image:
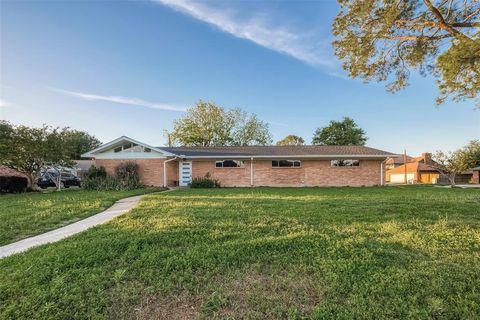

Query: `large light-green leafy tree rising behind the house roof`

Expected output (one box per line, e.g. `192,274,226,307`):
170,101,272,147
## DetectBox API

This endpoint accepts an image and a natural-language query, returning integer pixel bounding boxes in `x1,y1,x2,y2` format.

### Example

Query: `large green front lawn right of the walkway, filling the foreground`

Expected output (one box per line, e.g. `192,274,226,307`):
0,187,480,319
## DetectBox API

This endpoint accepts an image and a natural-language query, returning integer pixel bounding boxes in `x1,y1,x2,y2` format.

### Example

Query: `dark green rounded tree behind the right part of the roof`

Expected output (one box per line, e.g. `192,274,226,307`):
312,117,368,146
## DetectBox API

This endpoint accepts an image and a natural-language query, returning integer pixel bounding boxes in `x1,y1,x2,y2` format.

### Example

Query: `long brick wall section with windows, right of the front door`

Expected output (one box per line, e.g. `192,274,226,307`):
192,160,381,187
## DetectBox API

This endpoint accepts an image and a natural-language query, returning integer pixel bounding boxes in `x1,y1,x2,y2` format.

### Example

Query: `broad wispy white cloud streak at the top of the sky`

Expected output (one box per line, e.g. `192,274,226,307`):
153,0,335,66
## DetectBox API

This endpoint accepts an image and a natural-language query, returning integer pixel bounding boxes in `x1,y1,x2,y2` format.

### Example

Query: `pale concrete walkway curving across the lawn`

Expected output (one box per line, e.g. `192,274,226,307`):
0,195,142,259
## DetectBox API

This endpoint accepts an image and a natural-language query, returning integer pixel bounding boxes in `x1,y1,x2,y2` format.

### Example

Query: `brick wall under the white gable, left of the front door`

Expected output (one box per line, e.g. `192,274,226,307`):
95,159,178,186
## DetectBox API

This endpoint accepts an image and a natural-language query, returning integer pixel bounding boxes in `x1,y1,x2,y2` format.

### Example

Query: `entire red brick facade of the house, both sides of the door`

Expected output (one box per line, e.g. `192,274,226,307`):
95,159,381,187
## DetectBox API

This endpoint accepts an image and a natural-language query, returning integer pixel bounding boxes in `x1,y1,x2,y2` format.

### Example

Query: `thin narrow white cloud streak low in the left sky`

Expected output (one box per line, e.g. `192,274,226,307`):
49,88,186,112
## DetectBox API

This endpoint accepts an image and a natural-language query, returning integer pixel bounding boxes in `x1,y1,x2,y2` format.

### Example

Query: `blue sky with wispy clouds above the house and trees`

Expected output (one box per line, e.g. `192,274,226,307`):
0,0,480,154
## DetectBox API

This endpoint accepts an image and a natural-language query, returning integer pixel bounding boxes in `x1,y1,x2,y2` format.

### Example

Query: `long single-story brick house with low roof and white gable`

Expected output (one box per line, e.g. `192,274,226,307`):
82,136,396,187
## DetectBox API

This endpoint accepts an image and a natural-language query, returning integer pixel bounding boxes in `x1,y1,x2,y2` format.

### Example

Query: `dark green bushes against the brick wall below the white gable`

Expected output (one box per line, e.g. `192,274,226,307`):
82,162,144,191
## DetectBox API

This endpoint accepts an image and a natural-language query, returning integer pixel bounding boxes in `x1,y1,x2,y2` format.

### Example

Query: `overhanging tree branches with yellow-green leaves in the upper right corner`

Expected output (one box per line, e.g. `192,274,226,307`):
332,0,480,105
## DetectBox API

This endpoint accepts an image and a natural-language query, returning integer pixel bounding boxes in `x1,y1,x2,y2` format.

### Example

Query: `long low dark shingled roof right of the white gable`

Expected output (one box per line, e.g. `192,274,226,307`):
158,145,395,158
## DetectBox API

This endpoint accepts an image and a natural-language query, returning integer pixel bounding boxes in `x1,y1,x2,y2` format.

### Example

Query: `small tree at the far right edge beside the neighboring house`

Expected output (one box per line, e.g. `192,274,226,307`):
432,140,480,186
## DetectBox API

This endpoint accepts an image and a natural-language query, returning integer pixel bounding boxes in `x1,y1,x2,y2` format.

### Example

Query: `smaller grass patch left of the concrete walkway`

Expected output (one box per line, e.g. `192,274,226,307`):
0,188,164,246
